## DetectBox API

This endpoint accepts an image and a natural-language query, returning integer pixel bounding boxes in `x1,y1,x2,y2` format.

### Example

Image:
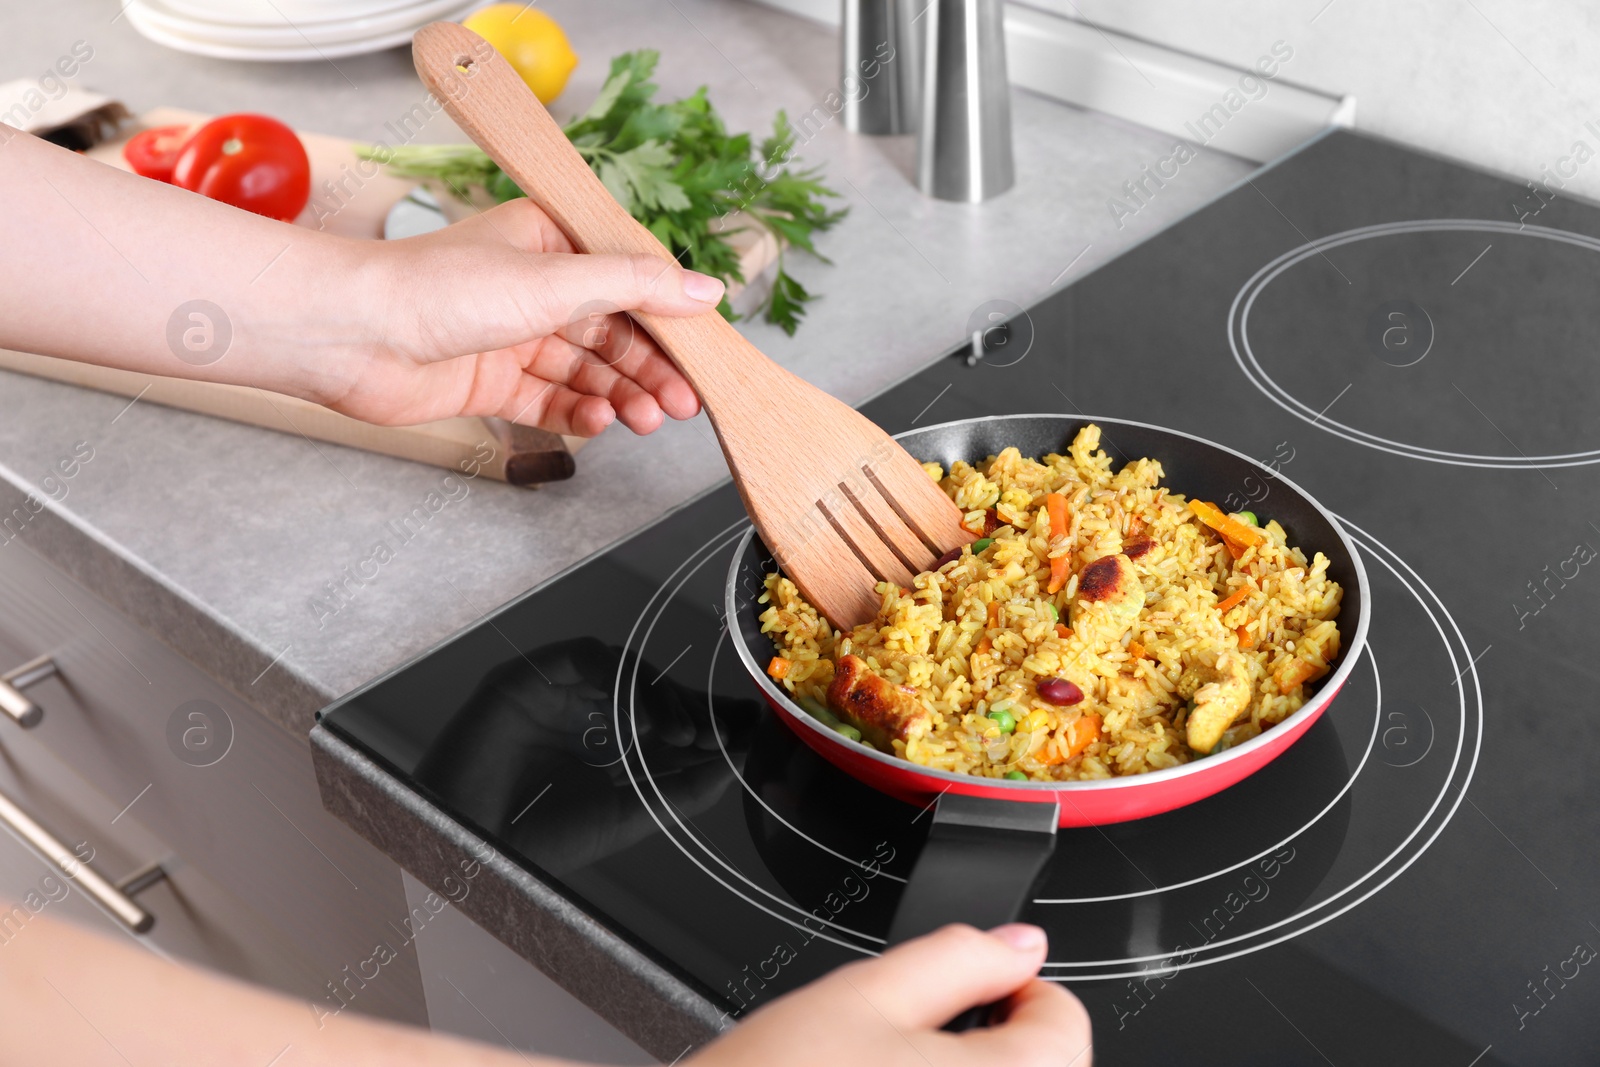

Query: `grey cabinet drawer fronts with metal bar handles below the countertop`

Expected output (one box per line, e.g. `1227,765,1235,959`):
0,542,426,1022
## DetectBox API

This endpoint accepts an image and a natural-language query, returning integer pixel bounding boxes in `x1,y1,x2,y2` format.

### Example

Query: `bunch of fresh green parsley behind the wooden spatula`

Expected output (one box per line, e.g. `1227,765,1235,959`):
368,48,845,334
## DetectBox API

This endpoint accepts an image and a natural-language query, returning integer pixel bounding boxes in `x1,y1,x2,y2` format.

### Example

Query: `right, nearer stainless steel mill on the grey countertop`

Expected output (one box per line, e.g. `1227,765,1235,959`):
917,0,1016,203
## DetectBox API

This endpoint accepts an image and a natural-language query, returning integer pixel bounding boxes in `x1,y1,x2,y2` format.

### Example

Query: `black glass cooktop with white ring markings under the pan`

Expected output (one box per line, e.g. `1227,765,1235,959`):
323,131,1600,1067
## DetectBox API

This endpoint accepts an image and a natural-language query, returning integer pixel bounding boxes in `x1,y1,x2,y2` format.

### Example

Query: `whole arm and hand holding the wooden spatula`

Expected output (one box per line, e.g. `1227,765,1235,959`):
0,133,723,437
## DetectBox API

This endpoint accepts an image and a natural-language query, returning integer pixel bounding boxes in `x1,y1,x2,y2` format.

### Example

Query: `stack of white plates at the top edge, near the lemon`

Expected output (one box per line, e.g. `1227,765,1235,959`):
126,0,490,61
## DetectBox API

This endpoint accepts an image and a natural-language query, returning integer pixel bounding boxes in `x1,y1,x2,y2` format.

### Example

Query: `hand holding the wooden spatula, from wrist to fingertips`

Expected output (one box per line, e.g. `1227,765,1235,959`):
326,200,723,437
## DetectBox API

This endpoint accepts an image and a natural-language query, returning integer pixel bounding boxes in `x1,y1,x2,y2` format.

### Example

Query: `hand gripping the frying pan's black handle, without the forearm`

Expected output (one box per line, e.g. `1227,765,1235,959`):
690,923,1094,1067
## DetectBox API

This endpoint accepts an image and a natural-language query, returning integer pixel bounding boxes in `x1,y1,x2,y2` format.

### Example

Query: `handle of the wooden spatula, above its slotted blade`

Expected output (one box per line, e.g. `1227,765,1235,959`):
411,22,764,416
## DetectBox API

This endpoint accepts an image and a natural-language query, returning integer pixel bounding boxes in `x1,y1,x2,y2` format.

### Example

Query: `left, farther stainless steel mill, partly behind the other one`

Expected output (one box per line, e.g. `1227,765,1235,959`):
838,0,918,134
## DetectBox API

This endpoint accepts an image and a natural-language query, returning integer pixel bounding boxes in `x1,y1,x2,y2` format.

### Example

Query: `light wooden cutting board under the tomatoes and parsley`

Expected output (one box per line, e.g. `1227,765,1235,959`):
0,107,778,486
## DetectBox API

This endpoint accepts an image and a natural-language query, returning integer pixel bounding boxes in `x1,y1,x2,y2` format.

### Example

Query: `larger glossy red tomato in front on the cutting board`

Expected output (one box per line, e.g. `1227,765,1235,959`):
173,115,310,222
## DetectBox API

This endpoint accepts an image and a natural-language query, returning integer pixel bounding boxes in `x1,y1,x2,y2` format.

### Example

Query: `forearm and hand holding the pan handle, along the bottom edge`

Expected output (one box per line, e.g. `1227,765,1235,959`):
0,896,1094,1067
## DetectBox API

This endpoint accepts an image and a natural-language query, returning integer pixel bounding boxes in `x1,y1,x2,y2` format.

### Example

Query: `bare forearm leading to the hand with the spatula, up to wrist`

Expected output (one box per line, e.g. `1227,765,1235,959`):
0,125,386,406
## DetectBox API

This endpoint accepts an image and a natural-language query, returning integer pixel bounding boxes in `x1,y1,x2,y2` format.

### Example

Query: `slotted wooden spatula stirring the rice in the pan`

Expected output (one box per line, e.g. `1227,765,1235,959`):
411,22,973,629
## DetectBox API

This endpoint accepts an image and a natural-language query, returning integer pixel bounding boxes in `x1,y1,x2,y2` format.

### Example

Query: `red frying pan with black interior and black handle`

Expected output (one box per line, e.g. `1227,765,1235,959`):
726,414,1370,944
